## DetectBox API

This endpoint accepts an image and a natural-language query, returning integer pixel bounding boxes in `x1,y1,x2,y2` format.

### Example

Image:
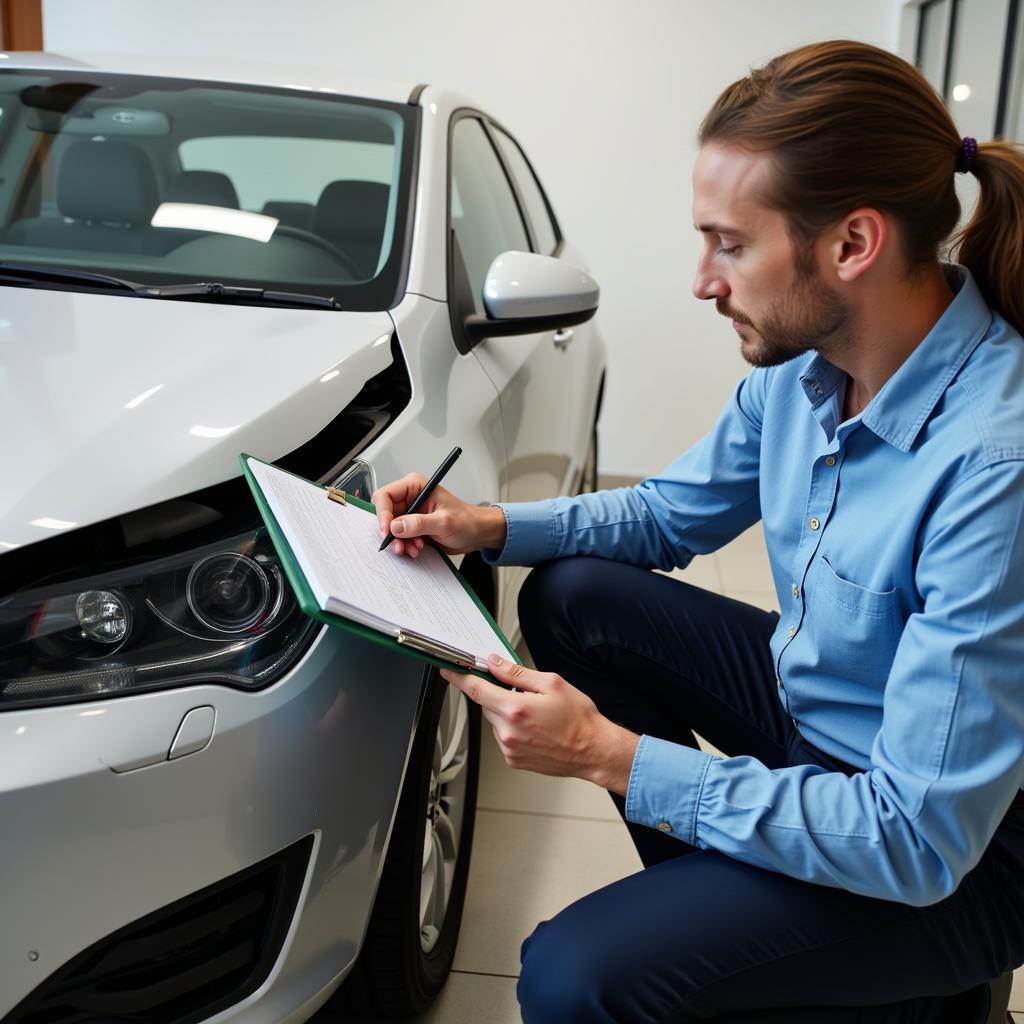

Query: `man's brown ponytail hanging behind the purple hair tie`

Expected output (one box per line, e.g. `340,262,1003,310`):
950,142,1024,334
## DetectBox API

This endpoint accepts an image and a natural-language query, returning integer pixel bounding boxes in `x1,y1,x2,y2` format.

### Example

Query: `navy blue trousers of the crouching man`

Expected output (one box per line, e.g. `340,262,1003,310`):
518,558,1024,1024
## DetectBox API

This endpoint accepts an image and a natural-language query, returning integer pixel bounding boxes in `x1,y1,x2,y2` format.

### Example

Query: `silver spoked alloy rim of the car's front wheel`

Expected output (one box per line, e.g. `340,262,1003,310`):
420,686,469,953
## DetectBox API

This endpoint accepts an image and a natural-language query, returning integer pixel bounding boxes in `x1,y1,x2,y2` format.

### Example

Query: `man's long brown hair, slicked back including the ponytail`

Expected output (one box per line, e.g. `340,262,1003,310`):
698,40,1024,331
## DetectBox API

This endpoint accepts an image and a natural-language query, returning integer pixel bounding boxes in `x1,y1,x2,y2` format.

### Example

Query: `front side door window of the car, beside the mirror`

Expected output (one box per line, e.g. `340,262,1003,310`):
451,118,529,313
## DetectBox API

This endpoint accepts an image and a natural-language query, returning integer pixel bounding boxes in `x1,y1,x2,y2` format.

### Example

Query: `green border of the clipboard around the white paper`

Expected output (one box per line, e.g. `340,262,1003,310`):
239,452,522,686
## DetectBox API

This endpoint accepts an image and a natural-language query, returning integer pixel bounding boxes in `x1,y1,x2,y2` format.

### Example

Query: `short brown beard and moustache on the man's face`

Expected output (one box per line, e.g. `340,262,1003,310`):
715,267,855,367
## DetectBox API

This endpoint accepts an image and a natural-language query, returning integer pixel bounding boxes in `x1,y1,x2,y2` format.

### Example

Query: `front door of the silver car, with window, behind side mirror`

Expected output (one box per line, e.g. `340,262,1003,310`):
449,112,575,501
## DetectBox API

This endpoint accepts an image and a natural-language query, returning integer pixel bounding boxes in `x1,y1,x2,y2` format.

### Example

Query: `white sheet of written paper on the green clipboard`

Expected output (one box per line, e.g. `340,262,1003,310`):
249,459,510,669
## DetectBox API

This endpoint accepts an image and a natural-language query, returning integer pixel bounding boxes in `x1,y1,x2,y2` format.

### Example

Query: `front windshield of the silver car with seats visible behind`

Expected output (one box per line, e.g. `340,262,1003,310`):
0,69,415,309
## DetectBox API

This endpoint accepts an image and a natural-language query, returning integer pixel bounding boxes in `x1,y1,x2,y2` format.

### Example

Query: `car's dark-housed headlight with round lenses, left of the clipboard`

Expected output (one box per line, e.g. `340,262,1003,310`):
0,529,318,711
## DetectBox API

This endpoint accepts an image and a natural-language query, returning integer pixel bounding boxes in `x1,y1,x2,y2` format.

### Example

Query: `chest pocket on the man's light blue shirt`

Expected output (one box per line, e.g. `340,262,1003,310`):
806,555,903,690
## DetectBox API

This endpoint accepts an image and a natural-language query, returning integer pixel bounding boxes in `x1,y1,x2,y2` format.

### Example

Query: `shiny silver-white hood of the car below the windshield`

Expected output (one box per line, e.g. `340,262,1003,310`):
0,288,392,556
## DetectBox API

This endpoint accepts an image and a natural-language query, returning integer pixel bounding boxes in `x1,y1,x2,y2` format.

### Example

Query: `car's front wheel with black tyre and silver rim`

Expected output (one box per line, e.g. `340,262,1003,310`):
334,669,480,1017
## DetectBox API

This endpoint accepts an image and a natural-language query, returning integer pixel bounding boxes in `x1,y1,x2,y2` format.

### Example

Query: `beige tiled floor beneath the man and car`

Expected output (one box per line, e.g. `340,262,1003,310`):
312,527,1024,1024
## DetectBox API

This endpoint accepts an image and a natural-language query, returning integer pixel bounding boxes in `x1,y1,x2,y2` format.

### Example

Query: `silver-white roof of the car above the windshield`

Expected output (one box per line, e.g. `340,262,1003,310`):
0,50,418,103
